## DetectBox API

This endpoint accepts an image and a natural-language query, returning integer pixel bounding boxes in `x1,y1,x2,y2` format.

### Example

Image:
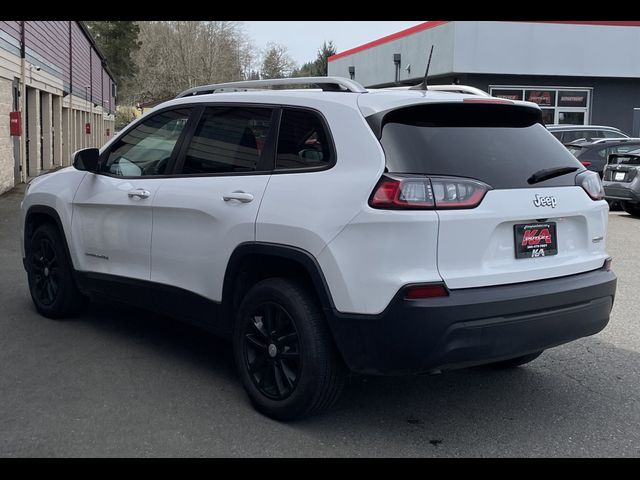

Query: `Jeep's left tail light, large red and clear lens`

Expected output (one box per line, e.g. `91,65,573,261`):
369,174,491,210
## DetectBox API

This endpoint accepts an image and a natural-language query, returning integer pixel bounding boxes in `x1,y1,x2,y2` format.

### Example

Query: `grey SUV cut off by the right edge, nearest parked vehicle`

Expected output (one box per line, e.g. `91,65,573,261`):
602,149,640,217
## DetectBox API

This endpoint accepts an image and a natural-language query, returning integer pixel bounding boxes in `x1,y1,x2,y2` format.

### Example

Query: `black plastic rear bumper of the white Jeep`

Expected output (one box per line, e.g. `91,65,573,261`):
329,270,616,375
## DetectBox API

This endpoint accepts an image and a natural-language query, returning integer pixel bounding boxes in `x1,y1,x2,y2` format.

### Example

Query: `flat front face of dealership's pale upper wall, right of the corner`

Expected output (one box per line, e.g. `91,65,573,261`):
456,22,640,78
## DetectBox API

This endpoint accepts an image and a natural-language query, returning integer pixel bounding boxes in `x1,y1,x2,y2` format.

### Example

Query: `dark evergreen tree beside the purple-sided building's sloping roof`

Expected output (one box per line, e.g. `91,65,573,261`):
85,21,141,96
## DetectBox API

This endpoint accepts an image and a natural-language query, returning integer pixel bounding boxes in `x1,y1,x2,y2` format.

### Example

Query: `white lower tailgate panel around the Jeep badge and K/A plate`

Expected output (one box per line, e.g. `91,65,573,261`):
438,187,609,289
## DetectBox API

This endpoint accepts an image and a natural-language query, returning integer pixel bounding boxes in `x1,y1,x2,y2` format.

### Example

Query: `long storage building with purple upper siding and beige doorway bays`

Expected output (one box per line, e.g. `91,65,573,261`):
0,21,115,193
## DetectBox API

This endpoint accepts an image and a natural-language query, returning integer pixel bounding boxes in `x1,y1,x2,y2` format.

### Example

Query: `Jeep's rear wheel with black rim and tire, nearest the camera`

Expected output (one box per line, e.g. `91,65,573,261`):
233,278,347,420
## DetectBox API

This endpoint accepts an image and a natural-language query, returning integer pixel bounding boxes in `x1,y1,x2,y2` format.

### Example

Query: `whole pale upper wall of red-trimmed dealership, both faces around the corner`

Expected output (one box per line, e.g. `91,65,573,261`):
328,21,640,87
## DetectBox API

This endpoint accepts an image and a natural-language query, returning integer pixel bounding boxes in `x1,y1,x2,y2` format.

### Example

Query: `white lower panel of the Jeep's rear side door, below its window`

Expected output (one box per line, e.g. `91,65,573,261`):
151,175,269,301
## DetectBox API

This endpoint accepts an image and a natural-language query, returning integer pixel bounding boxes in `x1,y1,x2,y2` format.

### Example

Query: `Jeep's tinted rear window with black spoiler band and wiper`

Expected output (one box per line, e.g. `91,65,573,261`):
380,104,584,189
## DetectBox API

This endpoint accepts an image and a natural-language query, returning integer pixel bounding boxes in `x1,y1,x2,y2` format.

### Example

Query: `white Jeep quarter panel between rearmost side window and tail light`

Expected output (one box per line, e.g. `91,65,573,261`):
256,104,384,256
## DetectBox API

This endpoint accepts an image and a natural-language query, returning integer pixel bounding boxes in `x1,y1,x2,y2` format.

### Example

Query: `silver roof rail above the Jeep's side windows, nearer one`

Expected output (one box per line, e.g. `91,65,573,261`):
176,77,367,98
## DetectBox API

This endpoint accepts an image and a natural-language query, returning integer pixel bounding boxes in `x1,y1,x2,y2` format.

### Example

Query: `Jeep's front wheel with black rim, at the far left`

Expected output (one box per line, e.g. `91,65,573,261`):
27,223,88,319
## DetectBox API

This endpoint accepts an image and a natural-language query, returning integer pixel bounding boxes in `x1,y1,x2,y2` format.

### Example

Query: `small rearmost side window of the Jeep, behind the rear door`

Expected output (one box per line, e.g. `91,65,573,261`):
276,109,332,170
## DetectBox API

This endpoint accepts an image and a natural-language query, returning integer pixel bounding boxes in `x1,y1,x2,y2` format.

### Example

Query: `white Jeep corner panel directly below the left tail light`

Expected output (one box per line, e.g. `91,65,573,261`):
318,210,442,314
